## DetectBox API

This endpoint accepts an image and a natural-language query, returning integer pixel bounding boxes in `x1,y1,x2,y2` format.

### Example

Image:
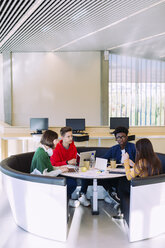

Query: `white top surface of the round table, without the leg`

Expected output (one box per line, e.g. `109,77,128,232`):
61,168,125,179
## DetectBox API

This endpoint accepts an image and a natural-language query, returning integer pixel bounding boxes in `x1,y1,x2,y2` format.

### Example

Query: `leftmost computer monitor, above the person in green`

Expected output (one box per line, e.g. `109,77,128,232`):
30,118,49,134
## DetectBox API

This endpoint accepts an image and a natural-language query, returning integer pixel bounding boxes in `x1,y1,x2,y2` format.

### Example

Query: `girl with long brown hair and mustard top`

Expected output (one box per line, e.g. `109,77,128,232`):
119,138,162,225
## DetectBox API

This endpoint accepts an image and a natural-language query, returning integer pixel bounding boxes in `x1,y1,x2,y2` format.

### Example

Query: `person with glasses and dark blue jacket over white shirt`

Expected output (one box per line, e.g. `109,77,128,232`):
100,127,136,204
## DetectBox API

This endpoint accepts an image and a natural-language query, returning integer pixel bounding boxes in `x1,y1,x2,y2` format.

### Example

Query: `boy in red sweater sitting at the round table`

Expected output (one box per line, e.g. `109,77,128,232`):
50,127,90,207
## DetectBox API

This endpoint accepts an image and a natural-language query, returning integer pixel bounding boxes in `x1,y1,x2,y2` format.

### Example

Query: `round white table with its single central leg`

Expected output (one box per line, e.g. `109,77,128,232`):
61,166,125,215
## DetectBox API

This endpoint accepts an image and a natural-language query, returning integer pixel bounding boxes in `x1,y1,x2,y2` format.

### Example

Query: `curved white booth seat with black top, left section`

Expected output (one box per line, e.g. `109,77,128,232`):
0,153,67,241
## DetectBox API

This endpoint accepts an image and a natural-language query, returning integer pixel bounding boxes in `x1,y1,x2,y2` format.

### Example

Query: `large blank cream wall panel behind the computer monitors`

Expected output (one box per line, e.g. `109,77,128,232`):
12,52,100,126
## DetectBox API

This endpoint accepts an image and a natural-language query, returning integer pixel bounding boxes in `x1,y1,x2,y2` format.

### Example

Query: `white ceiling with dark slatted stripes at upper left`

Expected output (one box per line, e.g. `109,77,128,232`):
0,0,165,59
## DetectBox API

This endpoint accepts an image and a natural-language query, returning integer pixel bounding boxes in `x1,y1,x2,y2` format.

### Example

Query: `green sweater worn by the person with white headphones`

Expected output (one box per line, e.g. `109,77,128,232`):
30,147,54,173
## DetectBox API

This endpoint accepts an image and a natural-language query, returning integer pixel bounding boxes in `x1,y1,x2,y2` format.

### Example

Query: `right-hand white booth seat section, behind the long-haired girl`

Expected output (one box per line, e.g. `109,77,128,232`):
128,174,165,242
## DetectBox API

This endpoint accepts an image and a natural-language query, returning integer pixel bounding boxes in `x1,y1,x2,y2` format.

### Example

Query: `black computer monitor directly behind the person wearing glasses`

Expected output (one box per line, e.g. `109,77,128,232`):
110,117,129,129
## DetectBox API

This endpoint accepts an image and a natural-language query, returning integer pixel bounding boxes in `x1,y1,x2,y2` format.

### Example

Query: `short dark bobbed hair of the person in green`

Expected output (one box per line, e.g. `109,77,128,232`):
40,130,58,148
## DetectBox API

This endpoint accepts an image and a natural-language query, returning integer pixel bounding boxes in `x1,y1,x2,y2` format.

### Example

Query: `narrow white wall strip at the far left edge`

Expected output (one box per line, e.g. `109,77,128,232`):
0,54,4,121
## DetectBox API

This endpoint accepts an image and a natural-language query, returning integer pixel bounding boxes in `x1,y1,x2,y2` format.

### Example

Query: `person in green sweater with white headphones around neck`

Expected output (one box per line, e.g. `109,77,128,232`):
30,130,80,207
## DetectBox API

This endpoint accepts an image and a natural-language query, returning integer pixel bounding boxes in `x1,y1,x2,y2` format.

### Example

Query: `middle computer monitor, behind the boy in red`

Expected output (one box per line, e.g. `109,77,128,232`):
66,118,85,132
